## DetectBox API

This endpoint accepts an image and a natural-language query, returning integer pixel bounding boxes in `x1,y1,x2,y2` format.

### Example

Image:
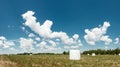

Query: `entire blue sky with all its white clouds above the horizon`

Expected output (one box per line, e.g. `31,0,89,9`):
0,0,120,54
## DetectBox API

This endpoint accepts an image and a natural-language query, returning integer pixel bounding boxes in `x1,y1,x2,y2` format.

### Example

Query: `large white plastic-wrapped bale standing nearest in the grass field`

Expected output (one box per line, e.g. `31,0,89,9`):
69,50,80,60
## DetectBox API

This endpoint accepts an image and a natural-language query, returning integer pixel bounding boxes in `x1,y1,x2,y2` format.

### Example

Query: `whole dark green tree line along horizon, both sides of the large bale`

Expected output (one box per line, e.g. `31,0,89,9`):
17,48,120,55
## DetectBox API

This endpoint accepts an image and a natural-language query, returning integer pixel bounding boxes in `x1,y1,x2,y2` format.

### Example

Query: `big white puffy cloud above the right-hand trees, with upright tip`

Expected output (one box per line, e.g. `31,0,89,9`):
84,22,112,45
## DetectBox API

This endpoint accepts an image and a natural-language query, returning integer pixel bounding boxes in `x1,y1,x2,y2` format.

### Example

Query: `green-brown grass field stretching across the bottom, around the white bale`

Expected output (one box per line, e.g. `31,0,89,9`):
0,55,120,67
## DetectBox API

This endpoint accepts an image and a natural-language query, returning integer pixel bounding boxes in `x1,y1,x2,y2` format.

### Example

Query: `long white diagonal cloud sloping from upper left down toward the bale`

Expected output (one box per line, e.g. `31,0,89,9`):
22,11,73,44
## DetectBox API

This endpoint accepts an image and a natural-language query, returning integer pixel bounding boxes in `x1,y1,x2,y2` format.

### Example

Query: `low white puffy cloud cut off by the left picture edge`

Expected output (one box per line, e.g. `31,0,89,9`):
0,36,15,48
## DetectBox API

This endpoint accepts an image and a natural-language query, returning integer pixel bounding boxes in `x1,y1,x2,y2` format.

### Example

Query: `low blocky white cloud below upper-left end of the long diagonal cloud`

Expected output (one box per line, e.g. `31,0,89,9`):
19,38,34,50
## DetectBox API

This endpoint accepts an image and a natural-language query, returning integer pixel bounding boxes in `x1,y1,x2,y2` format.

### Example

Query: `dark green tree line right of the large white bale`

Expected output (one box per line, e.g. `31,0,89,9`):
83,48,120,55
